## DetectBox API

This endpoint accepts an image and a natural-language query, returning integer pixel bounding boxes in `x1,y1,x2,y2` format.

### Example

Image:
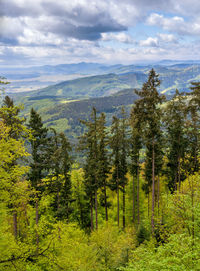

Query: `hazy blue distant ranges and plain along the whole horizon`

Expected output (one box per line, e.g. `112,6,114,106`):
3,60,200,93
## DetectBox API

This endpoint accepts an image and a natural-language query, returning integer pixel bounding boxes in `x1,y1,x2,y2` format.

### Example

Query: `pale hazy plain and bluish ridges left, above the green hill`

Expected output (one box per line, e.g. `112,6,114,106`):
0,62,122,93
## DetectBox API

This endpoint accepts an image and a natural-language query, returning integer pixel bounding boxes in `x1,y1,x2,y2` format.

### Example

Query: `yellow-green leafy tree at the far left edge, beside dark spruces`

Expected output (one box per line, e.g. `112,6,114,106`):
0,121,28,239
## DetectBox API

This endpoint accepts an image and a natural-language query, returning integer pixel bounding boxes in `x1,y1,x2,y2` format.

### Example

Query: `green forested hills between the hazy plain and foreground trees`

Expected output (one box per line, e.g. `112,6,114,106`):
11,63,200,139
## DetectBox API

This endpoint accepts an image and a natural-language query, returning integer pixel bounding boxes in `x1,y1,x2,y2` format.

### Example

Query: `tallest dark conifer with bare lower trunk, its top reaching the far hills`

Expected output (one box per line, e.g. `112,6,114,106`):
136,69,164,234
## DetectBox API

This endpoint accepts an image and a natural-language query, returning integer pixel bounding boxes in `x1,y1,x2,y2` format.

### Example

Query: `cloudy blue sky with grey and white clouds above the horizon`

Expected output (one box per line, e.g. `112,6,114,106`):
0,0,200,67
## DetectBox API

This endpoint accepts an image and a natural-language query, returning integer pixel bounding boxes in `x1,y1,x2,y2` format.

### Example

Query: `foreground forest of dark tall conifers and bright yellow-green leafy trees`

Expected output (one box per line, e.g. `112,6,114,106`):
0,69,200,271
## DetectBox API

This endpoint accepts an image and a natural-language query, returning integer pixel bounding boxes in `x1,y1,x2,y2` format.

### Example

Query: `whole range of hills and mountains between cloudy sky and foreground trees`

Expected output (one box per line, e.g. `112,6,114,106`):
3,60,200,140
